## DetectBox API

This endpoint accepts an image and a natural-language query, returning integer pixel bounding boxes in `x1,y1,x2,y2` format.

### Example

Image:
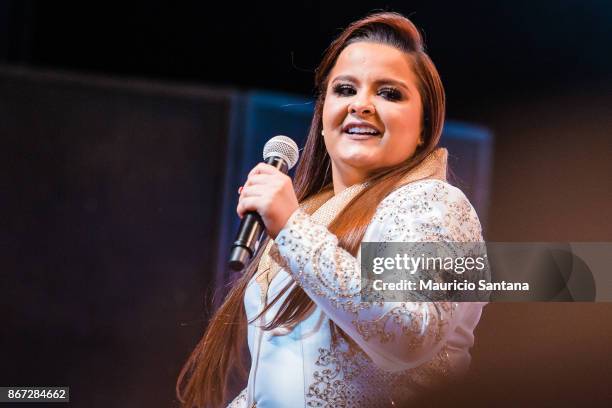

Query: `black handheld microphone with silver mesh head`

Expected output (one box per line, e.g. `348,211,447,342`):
229,136,299,271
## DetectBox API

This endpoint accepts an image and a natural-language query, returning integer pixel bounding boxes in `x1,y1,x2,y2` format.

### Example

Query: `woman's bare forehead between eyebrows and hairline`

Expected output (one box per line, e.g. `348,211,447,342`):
330,41,416,84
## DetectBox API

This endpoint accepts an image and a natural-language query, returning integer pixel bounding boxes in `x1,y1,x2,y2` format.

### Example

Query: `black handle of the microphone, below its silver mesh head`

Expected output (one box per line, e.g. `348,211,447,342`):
229,156,288,271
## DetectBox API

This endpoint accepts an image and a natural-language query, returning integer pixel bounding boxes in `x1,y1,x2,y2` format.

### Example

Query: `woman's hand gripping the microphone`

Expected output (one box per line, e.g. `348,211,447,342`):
236,163,298,239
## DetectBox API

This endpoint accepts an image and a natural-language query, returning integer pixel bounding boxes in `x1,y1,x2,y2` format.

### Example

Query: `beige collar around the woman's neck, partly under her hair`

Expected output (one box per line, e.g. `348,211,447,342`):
255,148,448,294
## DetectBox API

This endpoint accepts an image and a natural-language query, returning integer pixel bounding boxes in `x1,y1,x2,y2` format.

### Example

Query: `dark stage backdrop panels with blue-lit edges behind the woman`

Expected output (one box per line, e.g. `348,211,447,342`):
0,66,491,407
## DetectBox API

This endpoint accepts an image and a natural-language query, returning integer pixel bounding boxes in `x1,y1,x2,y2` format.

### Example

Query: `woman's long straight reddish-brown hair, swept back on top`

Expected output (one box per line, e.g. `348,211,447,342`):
176,12,445,408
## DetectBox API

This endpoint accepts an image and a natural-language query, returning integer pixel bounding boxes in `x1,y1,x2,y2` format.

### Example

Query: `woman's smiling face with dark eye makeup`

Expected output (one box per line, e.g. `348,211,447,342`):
323,42,423,187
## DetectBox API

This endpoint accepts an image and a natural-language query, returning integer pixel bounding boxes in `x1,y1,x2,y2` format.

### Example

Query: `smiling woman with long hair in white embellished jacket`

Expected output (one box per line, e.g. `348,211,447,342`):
177,13,482,408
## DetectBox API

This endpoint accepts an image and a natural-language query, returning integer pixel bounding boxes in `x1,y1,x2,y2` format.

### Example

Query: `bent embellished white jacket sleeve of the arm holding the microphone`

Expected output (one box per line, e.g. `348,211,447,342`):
271,180,482,371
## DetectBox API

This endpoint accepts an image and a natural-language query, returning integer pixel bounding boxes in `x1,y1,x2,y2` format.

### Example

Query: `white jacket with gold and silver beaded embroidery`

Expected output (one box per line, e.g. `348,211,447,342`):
230,180,484,408
